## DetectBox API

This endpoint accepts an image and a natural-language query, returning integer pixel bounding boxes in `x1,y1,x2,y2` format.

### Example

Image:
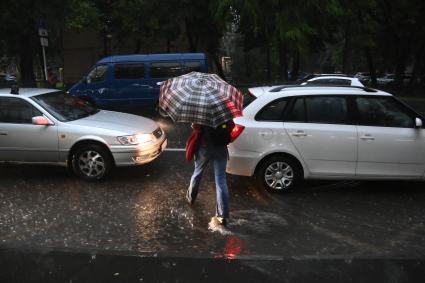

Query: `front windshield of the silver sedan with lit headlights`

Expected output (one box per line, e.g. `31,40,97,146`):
32,91,99,122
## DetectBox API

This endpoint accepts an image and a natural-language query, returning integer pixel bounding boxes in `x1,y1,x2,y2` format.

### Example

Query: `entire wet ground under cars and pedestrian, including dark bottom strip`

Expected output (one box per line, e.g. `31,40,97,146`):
0,106,425,282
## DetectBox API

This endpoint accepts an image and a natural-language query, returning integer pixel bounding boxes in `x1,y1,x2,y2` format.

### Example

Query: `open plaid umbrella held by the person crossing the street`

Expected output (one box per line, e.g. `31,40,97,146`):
159,72,243,128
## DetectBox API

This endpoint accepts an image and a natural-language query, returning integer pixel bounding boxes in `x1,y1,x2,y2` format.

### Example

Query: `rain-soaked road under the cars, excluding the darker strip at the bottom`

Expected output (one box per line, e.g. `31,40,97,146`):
0,105,425,282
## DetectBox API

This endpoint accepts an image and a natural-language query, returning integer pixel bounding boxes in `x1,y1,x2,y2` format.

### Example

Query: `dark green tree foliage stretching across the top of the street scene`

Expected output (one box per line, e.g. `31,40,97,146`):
0,0,425,85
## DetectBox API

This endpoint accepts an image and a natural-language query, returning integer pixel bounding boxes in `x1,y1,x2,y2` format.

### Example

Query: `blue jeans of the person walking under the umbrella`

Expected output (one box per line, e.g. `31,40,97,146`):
187,146,229,218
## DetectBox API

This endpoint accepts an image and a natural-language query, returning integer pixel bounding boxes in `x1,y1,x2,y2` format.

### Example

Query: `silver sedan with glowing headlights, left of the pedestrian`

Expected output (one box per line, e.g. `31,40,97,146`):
0,89,167,181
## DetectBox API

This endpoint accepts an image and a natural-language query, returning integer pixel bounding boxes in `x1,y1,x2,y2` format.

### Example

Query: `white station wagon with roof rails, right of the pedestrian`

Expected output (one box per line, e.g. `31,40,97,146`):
227,86,425,192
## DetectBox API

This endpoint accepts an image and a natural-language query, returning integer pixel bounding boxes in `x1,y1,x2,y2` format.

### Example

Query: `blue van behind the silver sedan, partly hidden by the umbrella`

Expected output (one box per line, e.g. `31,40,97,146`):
69,53,208,108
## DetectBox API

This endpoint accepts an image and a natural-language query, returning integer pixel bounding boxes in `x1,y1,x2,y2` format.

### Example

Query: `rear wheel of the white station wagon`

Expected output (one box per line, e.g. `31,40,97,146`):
256,155,302,193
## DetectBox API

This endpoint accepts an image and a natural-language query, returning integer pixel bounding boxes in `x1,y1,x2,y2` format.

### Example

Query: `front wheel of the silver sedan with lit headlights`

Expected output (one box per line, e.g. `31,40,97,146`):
72,144,113,181
